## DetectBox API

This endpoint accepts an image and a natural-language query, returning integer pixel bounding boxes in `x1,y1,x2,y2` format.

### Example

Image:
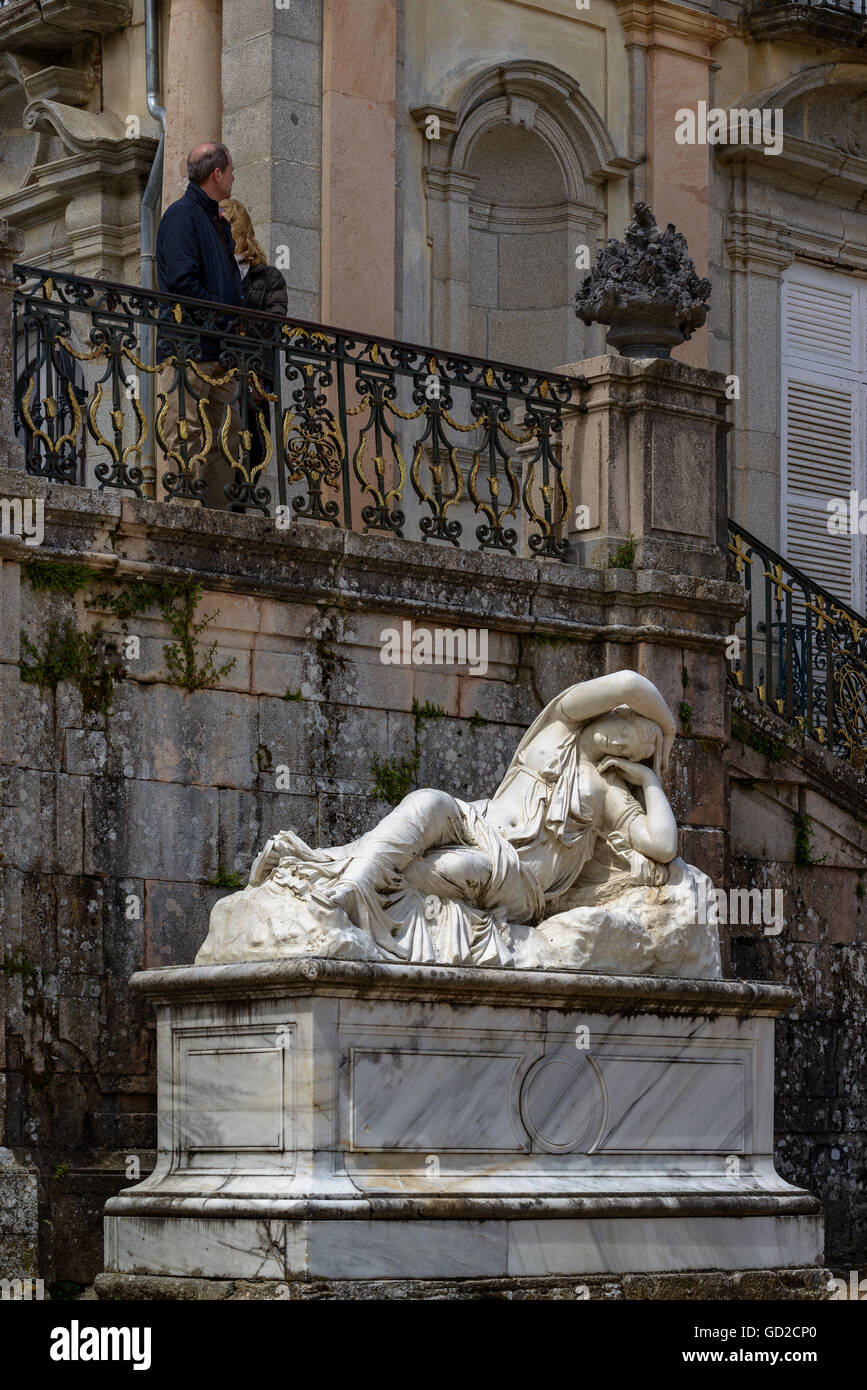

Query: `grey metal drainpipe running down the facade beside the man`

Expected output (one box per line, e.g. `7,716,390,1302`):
140,0,165,498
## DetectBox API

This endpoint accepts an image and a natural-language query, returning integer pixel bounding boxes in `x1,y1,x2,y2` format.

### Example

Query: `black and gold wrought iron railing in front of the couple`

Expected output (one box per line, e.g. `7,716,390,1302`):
13,265,586,560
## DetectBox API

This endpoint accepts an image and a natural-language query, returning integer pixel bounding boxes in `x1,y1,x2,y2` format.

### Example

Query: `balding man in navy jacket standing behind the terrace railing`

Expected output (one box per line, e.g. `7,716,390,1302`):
157,140,243,507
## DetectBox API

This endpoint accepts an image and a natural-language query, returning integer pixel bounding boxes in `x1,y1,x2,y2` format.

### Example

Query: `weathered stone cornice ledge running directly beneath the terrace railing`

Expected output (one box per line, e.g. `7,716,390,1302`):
0,470,743,639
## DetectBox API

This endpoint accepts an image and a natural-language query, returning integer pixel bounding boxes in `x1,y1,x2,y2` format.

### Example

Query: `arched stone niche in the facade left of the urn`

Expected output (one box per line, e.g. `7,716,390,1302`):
413,61,632,368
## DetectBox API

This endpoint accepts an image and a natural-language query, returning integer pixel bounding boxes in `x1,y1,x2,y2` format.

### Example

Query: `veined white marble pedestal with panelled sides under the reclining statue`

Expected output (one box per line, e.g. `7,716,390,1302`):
97,958,823,1297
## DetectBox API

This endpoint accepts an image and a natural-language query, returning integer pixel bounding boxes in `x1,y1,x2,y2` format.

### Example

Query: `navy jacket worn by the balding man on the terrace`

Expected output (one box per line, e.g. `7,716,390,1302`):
157,183,245,359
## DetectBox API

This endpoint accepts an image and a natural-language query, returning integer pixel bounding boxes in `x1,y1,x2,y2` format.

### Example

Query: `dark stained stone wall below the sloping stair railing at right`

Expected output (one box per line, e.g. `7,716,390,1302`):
727,698,867,1269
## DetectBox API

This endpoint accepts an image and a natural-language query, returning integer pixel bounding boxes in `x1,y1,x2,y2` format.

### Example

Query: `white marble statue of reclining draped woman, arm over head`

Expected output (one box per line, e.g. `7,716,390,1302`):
196,671,718,974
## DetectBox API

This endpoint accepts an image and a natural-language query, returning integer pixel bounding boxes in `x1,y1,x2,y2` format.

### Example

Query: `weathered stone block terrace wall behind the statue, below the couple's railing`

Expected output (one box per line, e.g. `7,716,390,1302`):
0,471,741,1283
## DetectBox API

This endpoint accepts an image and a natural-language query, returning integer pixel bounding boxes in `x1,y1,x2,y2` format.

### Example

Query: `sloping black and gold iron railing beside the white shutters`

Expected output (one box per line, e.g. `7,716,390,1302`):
728,521,867,773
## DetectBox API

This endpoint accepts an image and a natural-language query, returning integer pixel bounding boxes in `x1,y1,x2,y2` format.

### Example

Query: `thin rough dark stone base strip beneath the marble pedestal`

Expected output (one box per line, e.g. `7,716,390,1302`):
94,1269,831,1302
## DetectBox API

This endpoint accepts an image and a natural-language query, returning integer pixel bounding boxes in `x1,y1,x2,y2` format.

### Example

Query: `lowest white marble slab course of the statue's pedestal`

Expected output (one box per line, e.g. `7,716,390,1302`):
106,1195,821,1280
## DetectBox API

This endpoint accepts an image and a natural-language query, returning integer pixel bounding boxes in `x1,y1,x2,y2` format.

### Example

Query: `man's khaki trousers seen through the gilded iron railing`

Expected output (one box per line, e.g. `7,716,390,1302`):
157,361,240,510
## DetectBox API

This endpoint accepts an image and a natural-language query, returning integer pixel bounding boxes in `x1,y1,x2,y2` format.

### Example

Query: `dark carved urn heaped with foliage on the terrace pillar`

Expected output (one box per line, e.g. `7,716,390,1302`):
575,203,710,357
